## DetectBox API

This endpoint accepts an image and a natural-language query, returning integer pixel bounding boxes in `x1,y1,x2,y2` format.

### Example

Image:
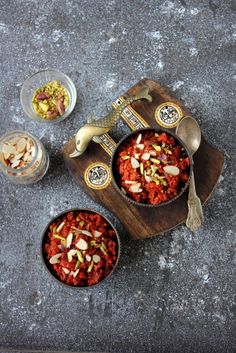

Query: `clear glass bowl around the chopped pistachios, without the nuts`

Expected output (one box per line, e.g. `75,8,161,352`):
20,69,77,124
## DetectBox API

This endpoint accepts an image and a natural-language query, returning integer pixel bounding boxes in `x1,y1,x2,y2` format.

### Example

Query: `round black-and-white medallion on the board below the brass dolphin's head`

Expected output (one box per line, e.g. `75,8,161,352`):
84,162,111,190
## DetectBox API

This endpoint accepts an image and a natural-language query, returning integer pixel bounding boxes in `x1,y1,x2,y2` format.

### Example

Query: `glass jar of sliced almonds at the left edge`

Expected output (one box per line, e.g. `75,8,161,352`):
0,131,49,184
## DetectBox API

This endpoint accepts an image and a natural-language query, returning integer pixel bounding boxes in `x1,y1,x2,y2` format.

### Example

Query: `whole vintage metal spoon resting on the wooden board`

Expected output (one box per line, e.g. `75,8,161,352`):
176,116,203,232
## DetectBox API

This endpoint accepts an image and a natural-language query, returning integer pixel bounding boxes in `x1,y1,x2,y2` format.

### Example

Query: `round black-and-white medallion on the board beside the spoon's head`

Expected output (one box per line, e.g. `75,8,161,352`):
155,102,183,129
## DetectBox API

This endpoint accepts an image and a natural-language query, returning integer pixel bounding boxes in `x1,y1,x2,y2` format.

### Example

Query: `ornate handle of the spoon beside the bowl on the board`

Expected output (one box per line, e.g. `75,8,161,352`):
186,173,203,233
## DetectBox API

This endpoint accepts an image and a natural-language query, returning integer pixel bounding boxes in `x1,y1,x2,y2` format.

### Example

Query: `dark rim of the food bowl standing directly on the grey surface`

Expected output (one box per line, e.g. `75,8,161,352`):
41,208,121,289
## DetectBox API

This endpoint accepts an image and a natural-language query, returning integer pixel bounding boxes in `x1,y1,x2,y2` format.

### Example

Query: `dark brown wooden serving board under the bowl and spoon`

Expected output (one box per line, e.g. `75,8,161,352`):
62,79,224,239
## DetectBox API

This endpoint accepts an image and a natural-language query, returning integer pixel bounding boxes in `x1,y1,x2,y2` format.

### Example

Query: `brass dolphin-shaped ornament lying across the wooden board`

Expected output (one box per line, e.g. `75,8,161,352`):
69,86,152,158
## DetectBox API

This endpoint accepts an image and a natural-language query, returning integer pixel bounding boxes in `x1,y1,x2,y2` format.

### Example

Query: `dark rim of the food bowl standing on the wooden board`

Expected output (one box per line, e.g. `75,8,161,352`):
110,127,193,207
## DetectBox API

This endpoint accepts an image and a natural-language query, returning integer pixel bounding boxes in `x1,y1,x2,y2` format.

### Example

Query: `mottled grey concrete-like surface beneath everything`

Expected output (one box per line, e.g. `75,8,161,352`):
0,0,236,353
